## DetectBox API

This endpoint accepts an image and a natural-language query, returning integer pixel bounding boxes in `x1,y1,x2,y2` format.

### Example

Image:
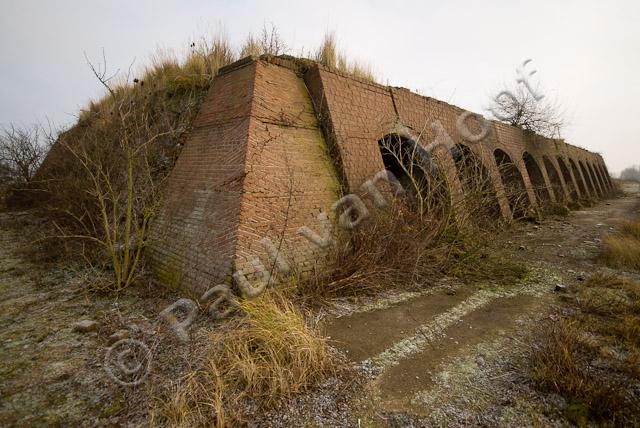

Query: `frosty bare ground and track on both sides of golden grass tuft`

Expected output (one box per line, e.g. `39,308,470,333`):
0,182,640,427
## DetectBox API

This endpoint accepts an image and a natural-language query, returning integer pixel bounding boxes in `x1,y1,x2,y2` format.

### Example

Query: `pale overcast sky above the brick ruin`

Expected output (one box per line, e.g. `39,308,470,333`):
0,0,640,172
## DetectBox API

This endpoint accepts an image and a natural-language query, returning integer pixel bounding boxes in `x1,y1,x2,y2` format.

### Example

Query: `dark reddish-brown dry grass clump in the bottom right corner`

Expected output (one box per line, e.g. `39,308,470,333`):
531,273,640,426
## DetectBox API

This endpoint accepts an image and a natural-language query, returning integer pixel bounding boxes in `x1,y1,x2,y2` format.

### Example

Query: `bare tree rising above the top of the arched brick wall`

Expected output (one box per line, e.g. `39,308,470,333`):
488,85,566,138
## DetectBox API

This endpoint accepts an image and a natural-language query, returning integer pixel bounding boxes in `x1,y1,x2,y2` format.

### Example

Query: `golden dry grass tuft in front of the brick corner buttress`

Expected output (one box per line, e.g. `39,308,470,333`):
155,291,336,426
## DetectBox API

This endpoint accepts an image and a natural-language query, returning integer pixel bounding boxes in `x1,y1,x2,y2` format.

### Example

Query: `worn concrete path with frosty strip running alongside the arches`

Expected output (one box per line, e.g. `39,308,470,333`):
326,187,639,424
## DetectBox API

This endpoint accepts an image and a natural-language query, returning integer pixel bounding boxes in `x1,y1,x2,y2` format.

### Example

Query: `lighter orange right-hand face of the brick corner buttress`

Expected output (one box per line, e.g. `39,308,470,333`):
235,61,340,273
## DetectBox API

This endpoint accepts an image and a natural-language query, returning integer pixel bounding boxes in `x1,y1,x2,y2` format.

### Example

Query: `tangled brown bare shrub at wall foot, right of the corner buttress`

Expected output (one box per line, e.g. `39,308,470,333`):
296,201,451,304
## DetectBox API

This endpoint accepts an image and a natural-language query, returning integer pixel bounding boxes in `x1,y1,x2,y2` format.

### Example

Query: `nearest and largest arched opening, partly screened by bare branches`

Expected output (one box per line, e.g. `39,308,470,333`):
378,134,449,216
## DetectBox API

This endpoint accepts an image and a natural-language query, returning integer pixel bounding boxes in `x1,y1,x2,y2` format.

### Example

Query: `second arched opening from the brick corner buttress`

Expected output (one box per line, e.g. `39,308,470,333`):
451,144,500,221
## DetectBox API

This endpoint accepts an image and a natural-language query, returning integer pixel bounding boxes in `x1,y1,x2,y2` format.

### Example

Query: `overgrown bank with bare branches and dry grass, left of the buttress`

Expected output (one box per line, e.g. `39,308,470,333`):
38,44,228,290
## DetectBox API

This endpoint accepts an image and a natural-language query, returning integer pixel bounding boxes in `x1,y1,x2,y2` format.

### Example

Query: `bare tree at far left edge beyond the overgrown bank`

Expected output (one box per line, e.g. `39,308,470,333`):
0,125,48,183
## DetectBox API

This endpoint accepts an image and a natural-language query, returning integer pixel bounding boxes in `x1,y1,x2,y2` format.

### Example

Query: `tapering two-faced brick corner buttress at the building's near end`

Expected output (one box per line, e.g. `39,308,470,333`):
149,61,340,296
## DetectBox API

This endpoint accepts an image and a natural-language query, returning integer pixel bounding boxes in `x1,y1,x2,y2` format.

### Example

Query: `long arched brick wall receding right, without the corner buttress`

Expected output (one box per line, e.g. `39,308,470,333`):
305,65,611,218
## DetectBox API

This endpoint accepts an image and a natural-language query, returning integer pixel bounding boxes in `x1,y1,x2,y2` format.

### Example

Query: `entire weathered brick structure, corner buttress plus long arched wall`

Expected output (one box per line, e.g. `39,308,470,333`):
149,57,612,295
